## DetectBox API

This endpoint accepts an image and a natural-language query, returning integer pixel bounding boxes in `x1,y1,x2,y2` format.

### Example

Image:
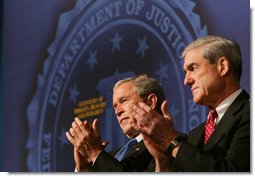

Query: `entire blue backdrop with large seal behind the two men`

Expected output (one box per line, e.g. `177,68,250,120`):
0,0,250,172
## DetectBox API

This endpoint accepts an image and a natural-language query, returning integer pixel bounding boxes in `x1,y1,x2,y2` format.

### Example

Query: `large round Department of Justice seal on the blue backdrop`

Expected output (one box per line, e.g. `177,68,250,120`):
27,0,207,172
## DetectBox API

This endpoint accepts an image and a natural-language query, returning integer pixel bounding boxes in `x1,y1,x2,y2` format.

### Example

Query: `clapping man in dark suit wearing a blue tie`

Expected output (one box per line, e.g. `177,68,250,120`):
66,75,165,172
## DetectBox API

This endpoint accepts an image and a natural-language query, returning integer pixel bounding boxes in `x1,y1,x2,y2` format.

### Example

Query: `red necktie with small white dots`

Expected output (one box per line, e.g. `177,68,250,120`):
204,109,218,143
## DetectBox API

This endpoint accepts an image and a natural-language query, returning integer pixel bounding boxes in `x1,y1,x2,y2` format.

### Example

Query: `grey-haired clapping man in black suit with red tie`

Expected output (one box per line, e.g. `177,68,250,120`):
130,36,250,172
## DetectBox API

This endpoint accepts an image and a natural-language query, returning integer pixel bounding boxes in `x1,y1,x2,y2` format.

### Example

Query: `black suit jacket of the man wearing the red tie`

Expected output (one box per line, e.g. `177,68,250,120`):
173,91,250,172
